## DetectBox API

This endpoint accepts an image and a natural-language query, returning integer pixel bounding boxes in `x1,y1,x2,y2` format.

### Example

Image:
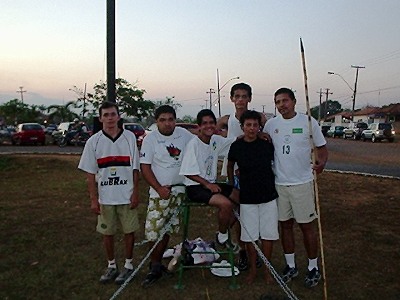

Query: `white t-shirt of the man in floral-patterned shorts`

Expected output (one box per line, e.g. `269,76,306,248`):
140,127,194,198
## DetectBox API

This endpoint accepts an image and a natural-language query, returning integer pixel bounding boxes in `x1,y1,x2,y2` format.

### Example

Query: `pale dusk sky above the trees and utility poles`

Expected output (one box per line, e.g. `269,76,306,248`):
0,0,400,117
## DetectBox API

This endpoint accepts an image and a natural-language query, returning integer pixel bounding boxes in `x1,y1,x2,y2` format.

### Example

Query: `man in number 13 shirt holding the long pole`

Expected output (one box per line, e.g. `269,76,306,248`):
264,88,328,287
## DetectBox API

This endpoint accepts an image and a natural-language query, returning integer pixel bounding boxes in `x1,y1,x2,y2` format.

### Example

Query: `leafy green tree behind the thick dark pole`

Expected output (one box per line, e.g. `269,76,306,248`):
87,78,155,120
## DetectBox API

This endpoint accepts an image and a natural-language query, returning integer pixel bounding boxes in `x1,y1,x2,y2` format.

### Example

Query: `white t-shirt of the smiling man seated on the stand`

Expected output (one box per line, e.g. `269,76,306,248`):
179,134,236,185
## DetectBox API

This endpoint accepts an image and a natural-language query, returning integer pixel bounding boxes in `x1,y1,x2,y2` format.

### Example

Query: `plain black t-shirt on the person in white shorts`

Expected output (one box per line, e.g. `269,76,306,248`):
228,138,278,204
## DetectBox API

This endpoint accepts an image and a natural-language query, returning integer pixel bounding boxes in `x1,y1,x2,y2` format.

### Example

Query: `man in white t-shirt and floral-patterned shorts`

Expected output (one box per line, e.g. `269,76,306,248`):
140,105,194,287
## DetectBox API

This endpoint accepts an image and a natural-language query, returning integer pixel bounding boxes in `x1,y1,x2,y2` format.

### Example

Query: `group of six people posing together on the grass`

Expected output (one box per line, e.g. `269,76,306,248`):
78,83,328,287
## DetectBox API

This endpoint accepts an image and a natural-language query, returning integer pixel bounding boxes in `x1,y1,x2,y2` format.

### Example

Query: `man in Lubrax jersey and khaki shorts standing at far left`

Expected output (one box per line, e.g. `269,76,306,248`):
78,102,139,284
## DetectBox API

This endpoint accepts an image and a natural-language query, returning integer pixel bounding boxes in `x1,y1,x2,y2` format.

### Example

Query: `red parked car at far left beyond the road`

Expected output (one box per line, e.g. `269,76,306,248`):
11,123,46,145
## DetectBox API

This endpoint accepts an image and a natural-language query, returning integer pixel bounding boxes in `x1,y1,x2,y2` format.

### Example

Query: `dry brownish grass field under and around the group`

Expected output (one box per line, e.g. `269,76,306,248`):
0,155,400,300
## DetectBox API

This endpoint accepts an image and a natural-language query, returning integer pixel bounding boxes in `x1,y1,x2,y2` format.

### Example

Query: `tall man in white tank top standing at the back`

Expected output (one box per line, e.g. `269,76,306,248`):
217,83,266,271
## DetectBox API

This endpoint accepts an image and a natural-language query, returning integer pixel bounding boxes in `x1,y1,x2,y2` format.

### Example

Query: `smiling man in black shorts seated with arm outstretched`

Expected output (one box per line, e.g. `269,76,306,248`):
179,109,238,247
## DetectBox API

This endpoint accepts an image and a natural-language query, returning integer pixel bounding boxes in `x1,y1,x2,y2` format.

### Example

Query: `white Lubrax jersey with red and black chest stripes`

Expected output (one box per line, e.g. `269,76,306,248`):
78,130,139,205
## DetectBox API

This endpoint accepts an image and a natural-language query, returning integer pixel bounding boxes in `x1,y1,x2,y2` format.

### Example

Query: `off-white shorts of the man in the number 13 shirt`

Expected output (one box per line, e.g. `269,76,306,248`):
276,181,317,224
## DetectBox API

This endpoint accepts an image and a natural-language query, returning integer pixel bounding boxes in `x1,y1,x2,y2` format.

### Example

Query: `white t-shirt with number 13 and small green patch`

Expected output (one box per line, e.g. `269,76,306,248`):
263,113,326,185
